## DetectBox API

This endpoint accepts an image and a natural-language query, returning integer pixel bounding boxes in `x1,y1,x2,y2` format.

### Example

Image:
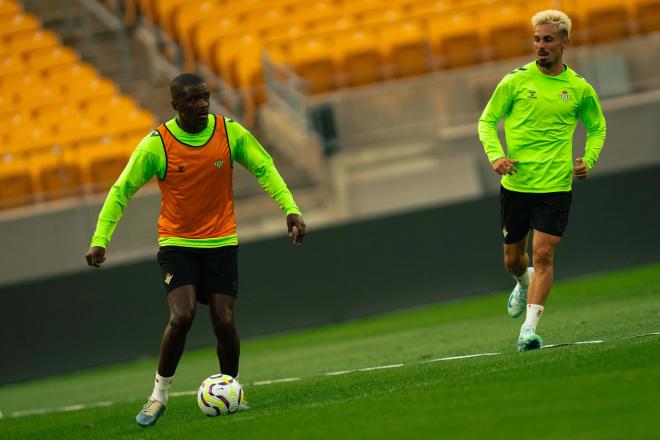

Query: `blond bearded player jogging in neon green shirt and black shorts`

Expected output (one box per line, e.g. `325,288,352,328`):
479,10,605,351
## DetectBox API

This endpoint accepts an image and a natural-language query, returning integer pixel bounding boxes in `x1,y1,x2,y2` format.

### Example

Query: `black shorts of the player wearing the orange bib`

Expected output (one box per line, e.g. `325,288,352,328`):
158,246,238,304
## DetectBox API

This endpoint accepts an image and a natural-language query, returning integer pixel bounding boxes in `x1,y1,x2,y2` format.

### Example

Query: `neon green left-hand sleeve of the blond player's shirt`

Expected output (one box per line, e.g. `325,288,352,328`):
478,77,514,163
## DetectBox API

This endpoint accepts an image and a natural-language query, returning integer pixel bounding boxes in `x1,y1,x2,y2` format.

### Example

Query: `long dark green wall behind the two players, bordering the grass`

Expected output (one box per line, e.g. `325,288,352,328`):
0,166,660,383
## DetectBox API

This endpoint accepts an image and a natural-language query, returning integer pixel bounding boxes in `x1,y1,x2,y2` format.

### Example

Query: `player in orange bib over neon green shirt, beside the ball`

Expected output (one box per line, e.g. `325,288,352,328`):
85,73,305,426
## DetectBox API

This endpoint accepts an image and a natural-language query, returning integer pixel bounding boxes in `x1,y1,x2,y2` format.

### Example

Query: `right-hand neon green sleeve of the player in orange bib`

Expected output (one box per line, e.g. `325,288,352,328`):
225,119,301,215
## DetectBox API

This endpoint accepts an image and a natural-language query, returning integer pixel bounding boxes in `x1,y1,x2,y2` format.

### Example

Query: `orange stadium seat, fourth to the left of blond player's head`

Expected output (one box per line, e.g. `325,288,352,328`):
336,29,385,87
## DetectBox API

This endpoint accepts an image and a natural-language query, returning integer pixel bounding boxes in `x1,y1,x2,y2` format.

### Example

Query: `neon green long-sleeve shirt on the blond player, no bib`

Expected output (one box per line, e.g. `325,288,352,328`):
479,61,606,193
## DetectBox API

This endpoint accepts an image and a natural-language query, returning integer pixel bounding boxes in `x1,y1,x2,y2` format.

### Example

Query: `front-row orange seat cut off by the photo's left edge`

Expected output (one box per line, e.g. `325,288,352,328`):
0,156,33,209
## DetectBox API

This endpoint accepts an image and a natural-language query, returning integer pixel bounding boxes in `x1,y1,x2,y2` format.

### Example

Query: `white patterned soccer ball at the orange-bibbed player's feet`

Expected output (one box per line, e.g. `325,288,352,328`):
197,374,243,417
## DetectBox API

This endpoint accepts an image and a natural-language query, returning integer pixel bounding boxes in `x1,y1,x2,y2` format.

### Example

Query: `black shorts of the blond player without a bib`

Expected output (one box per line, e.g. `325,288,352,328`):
500,187,571,244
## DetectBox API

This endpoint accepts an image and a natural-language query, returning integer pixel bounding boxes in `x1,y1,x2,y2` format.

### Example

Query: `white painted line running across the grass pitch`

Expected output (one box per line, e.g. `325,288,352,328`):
0,332,660,419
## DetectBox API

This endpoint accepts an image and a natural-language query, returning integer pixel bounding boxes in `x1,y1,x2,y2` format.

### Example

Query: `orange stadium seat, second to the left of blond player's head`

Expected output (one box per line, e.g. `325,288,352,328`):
429,13,483,69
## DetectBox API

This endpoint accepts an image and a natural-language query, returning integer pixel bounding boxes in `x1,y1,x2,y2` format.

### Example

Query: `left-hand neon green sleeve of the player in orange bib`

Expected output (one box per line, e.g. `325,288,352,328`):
91,136,165,248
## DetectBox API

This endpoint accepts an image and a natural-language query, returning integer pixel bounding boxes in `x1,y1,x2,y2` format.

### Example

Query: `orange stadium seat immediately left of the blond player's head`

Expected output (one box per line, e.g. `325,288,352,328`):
488,4,532,60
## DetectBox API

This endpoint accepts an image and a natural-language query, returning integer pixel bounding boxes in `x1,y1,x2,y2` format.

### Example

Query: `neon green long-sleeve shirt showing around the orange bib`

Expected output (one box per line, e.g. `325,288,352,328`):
91,115,300,248
